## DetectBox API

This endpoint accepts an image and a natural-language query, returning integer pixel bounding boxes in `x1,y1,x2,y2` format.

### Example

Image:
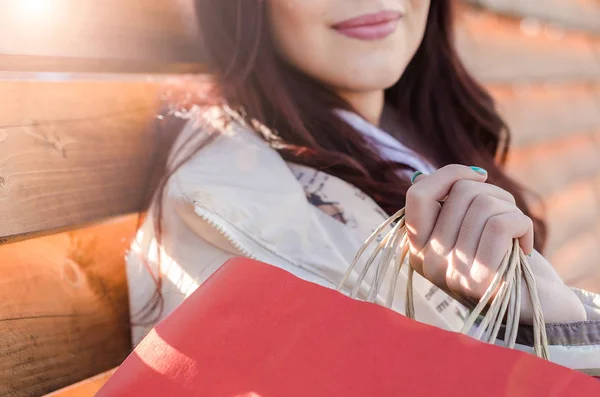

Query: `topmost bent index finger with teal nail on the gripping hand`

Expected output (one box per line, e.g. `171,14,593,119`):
406,165,487,252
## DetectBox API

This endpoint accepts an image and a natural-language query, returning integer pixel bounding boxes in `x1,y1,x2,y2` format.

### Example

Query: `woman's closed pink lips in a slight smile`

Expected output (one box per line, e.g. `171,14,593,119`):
332,11,403,40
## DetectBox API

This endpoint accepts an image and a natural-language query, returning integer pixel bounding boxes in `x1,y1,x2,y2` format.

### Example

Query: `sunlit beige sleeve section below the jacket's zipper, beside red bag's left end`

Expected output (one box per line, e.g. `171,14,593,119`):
126,176,238,346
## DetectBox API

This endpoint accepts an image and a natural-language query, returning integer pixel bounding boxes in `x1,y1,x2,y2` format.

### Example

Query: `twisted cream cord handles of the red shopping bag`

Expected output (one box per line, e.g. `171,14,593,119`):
338,209,549,360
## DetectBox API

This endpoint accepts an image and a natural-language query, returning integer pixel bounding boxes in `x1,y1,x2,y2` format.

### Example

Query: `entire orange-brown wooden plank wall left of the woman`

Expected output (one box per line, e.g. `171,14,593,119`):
0,0,202,397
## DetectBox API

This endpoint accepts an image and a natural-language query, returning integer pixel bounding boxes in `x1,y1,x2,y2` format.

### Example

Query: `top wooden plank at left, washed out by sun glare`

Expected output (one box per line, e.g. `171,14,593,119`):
0,0,204,72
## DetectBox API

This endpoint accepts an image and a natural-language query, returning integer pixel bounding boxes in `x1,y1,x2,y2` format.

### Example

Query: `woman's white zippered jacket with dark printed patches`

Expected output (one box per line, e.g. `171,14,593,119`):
127,109,600,376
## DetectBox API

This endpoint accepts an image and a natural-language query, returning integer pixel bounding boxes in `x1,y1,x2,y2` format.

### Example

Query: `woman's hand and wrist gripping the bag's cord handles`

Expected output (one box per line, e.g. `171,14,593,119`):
406,165,586,324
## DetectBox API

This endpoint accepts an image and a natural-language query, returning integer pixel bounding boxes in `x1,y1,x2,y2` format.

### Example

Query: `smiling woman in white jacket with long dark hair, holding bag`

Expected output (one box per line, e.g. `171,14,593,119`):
128,0,600,368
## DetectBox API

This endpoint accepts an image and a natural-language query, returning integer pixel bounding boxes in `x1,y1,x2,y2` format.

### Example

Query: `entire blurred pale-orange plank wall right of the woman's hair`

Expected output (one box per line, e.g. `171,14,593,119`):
457,0,600,292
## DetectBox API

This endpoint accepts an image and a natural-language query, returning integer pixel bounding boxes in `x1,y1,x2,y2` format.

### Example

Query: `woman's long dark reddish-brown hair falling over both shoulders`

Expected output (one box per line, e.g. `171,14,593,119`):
138,0,546,322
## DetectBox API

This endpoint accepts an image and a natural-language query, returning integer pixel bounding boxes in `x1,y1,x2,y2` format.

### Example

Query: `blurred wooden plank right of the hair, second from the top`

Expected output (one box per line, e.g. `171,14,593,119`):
456,7,600,83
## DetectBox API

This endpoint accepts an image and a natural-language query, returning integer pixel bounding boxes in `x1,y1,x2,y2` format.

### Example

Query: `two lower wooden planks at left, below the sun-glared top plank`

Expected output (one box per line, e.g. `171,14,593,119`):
0,76,183,397
